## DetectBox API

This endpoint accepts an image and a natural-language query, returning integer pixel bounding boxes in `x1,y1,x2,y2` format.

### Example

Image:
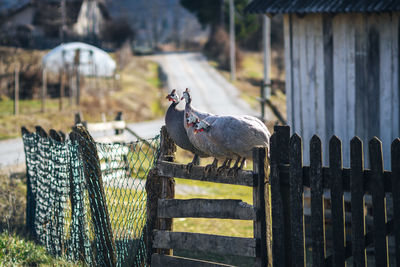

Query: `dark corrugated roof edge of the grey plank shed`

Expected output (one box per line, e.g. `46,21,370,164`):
245,0,400,14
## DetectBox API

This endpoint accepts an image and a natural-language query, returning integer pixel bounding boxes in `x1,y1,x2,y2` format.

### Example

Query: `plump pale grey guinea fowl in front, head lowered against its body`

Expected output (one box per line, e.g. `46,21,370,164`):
188,114,271,175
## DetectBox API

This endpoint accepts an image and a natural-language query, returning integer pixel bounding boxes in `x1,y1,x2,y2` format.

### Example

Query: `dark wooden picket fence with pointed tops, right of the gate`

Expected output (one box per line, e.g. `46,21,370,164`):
269,126,400,266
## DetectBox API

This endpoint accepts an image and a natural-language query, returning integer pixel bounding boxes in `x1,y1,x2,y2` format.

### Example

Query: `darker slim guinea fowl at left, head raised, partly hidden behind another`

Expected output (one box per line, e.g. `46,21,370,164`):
165,89,207,168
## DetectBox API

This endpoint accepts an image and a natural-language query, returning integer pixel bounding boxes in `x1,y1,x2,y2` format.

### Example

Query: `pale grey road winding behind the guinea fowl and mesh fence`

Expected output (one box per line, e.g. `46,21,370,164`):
0,53,272,169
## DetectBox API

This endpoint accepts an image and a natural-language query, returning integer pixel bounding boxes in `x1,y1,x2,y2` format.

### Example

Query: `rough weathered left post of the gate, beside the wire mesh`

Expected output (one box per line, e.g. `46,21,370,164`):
146,126,176,264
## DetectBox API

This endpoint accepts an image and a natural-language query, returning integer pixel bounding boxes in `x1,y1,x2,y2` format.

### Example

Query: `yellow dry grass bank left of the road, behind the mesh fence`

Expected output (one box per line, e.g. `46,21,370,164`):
0,49,166,140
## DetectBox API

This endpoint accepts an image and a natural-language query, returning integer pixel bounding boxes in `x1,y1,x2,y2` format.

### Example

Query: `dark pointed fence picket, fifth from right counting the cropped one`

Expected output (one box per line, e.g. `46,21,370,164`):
310,135,326,266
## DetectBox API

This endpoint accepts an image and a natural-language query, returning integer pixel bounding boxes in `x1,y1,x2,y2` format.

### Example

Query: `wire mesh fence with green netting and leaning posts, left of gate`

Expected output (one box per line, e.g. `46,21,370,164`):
22,127,160,266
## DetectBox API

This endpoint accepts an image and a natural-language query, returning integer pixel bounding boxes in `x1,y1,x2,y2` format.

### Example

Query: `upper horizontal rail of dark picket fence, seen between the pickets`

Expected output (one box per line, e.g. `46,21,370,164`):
279,164,392,193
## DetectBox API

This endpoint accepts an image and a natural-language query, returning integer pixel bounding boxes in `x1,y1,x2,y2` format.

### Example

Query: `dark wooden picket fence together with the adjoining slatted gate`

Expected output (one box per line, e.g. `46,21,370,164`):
146,126,400,266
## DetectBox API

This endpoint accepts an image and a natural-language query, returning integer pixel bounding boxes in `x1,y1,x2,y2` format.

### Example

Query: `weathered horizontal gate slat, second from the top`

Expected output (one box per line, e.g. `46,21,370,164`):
158,199,257,221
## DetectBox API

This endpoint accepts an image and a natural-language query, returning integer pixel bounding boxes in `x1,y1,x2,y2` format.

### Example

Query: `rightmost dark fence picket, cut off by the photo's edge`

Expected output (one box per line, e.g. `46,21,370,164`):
391,138,400,262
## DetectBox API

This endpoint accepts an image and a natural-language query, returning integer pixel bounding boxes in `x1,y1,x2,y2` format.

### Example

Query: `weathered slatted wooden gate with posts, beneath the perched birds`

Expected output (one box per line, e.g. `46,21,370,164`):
146,127,271,266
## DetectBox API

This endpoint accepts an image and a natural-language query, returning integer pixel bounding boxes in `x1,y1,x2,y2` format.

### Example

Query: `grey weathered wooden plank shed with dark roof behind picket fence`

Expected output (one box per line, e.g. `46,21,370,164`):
246,0,400,169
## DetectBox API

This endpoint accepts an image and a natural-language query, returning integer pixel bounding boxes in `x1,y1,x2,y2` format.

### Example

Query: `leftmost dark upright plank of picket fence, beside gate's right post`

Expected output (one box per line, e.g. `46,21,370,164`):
269,134,290,266
